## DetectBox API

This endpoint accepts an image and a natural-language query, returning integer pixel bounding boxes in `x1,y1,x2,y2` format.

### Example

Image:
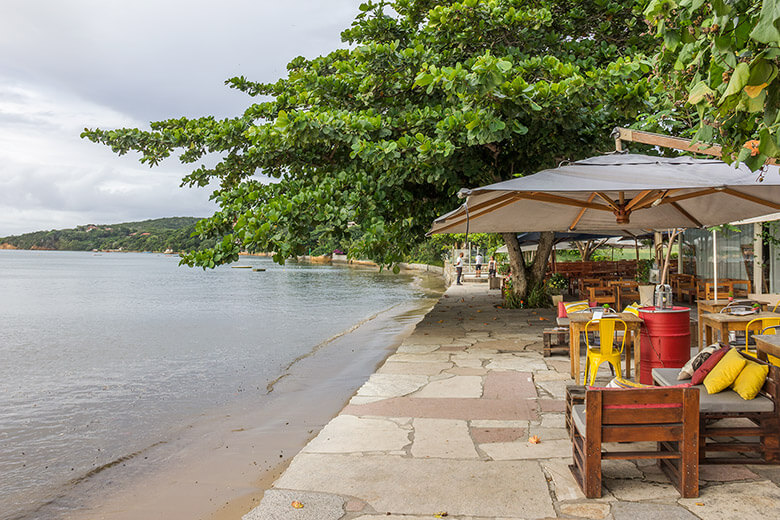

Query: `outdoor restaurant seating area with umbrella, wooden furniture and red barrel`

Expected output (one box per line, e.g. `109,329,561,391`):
432,133,780,497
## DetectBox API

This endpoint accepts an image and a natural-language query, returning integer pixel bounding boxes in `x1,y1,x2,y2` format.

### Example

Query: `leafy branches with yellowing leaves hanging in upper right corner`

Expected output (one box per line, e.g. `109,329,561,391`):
645,0,780,170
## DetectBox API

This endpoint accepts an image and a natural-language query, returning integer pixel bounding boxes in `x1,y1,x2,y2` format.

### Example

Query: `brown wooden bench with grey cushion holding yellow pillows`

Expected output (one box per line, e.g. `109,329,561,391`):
653,352,780,464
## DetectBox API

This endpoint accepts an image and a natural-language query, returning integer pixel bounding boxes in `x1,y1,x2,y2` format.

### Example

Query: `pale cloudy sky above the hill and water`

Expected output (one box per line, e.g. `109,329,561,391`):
0,0,361,237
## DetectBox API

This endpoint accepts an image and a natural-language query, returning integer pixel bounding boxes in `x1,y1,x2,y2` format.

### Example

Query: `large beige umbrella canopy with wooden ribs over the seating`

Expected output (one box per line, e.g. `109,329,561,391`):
430,154,780,234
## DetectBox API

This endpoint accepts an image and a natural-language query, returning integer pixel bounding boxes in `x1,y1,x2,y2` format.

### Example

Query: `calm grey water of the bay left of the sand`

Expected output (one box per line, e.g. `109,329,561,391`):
0,251,432,520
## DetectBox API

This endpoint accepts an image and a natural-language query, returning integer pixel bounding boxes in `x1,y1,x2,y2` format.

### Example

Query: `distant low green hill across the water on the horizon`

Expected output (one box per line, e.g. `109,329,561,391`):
0,217,214,251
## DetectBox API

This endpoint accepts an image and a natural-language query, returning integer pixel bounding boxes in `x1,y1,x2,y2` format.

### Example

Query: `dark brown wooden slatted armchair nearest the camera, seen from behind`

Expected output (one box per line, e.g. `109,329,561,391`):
569,388,699,498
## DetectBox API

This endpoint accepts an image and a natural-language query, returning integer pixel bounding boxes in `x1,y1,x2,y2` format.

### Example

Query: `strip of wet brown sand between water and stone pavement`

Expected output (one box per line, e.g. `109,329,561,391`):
58,277,443,520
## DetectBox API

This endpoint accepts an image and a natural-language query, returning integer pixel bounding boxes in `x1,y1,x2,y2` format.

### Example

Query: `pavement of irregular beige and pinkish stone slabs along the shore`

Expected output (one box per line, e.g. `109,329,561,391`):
244,284,780,520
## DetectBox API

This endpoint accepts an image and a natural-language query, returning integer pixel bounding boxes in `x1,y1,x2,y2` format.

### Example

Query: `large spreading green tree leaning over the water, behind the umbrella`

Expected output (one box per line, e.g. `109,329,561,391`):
82,0,652,294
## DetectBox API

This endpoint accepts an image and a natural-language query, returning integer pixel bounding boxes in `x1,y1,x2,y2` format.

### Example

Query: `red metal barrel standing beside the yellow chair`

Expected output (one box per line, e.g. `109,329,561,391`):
639,307,691,385
